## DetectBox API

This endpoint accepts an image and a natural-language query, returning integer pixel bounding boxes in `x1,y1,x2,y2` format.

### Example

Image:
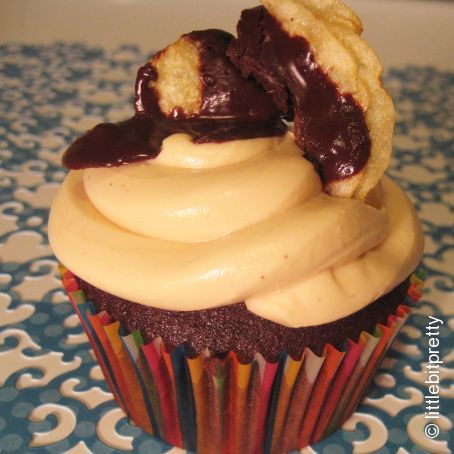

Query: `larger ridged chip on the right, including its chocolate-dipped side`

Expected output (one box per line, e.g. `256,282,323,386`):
228,0,394,199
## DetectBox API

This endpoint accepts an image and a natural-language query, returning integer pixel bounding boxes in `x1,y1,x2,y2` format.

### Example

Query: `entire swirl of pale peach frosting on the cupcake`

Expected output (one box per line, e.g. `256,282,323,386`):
49,133,422,326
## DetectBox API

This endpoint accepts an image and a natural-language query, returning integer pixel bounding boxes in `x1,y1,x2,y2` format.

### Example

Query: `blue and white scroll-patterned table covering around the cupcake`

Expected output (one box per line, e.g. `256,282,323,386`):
0,43,454,454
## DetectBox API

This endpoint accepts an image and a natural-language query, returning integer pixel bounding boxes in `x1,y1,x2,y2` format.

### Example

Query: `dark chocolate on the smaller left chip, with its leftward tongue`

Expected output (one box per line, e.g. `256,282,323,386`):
63,30,287,169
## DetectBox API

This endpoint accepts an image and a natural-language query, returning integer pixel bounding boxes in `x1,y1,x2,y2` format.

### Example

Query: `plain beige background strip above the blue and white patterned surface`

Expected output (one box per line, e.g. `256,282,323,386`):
0,0,454,69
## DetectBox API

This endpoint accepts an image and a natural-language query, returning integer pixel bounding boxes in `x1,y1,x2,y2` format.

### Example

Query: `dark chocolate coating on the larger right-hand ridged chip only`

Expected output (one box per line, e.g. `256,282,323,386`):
228,6,370,183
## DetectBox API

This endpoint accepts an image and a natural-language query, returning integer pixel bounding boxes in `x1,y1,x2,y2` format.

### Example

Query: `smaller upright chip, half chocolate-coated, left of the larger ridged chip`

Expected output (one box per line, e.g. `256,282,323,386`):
145,29,279,119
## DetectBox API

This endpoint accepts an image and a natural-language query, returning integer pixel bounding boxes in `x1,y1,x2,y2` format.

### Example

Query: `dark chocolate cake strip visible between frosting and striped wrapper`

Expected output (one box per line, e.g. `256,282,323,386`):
76,278,410,364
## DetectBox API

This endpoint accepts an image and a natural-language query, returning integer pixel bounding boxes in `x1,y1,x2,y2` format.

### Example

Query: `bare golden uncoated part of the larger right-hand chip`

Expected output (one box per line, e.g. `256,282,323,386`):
262,0,395,199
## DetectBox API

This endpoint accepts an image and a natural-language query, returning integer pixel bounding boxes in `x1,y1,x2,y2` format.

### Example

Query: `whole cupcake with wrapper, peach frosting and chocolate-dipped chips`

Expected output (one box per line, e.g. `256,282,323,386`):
49,0,423,454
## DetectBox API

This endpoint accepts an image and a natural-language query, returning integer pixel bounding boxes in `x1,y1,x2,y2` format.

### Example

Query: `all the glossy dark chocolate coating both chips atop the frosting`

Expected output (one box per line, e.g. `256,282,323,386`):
63,11,371,178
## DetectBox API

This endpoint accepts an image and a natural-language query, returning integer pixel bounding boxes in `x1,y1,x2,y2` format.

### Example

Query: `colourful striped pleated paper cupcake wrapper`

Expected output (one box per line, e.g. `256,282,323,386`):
61,267,423,454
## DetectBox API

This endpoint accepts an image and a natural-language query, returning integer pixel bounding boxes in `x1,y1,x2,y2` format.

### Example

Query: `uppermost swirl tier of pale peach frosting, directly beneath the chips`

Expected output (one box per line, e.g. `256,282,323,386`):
84,134,321,242
